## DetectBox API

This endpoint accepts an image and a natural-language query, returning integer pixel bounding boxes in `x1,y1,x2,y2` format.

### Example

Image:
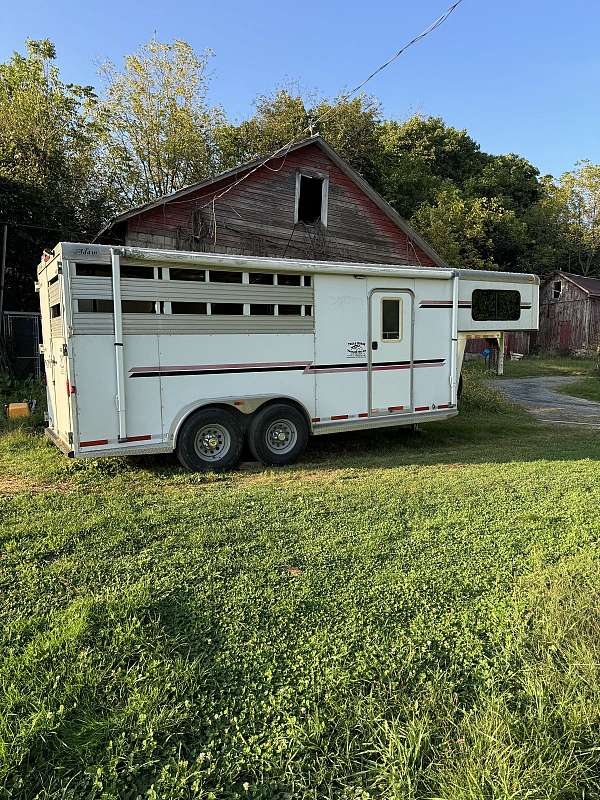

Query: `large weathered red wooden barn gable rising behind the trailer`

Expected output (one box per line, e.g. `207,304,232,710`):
96,136,445,267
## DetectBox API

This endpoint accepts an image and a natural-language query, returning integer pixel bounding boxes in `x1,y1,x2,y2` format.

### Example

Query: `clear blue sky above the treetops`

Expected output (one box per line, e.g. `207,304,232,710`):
0,0,600,175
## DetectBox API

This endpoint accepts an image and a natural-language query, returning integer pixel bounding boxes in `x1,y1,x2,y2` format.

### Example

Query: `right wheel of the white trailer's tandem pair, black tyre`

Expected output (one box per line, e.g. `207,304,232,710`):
248,403,308,466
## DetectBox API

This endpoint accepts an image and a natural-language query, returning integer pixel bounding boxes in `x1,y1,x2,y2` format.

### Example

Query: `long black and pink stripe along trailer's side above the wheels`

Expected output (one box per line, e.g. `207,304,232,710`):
129,358,446,378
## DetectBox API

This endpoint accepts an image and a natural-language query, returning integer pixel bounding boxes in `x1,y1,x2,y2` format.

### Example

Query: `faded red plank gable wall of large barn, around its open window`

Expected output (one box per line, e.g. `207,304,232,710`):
120,144,436,266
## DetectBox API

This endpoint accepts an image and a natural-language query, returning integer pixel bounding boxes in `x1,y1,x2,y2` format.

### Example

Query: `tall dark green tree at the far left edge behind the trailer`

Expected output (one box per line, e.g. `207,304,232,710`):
0,39,115,309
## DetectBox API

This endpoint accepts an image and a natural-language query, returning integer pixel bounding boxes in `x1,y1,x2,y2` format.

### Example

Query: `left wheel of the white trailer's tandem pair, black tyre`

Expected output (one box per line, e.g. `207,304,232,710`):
177,408,244,472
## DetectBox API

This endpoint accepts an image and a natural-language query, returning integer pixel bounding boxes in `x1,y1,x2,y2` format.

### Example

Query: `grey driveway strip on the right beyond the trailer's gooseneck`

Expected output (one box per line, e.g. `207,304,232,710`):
494,376,600,429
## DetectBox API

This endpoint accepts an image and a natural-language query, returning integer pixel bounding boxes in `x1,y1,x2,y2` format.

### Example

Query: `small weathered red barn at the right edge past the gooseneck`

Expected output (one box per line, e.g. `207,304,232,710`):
535,272,600,353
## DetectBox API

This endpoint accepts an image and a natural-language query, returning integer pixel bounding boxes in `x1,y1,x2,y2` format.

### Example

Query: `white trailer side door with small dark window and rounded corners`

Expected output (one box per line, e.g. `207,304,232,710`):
368,289,413,414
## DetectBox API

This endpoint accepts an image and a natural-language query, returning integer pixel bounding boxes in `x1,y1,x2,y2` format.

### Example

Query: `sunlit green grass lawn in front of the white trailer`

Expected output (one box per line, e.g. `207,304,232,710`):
0,377,600,800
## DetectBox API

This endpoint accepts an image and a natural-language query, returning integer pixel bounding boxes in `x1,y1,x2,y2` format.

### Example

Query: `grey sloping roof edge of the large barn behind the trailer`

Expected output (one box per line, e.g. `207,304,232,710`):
94,134,448,267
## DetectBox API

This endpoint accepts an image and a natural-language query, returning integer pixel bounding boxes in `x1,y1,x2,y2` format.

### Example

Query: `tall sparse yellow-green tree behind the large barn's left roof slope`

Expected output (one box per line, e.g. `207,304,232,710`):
99,39,222,205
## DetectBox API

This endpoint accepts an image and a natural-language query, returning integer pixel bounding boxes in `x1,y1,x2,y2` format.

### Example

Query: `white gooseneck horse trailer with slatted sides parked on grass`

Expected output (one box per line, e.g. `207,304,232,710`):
37,243,539,469
